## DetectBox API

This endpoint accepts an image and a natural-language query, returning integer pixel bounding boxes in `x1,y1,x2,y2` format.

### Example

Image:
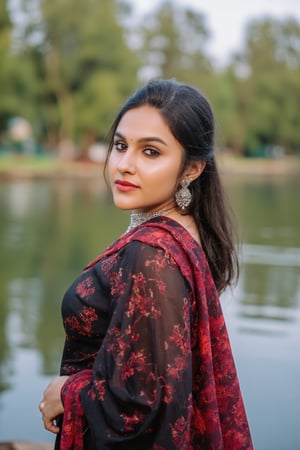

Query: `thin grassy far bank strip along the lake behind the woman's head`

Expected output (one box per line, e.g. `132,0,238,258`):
0,154,300,181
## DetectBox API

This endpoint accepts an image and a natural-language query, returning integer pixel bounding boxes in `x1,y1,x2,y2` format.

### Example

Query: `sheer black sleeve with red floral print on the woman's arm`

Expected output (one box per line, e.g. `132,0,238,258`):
62,242,192,450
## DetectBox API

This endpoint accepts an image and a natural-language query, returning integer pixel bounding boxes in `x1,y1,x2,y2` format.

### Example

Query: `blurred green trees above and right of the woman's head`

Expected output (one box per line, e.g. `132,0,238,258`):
137,1,300,154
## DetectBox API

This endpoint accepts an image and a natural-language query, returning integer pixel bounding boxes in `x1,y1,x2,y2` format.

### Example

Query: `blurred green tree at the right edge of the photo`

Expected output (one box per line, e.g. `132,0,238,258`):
233,19,300,153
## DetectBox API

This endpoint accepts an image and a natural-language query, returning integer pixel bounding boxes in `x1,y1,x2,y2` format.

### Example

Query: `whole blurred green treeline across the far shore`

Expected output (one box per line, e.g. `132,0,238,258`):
0,0,300,157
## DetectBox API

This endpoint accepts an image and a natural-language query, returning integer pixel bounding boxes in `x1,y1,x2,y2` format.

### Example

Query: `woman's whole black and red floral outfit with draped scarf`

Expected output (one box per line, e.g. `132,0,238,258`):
56,217,252,450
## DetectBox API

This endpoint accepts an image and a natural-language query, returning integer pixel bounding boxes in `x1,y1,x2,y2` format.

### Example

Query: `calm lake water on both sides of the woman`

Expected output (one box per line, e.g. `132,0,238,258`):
0,176,300,450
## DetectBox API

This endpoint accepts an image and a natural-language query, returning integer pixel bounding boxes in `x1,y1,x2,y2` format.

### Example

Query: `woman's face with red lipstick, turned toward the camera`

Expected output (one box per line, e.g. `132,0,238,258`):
108,106,184,212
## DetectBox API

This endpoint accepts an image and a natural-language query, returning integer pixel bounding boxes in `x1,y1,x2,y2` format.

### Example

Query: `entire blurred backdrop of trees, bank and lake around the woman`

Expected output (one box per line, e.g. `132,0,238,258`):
0,0,300,450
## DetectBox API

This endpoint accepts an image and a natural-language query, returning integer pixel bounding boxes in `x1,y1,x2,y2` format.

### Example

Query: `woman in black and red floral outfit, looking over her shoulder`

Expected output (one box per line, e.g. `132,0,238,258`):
40,81,252,450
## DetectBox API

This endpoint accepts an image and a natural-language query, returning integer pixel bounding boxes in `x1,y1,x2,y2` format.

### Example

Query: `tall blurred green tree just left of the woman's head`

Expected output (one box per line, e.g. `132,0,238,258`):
41,0,138,157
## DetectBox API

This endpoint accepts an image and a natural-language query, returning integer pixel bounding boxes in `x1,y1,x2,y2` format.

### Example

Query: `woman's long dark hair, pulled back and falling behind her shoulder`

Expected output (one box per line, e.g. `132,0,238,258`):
105,80,238,292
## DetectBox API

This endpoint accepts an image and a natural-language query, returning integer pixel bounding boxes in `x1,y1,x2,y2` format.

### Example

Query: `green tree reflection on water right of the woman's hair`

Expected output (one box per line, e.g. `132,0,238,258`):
225,176,300,249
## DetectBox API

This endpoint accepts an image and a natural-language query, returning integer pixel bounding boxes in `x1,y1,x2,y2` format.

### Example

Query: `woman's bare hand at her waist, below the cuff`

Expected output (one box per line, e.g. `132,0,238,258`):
39,376,68,434
